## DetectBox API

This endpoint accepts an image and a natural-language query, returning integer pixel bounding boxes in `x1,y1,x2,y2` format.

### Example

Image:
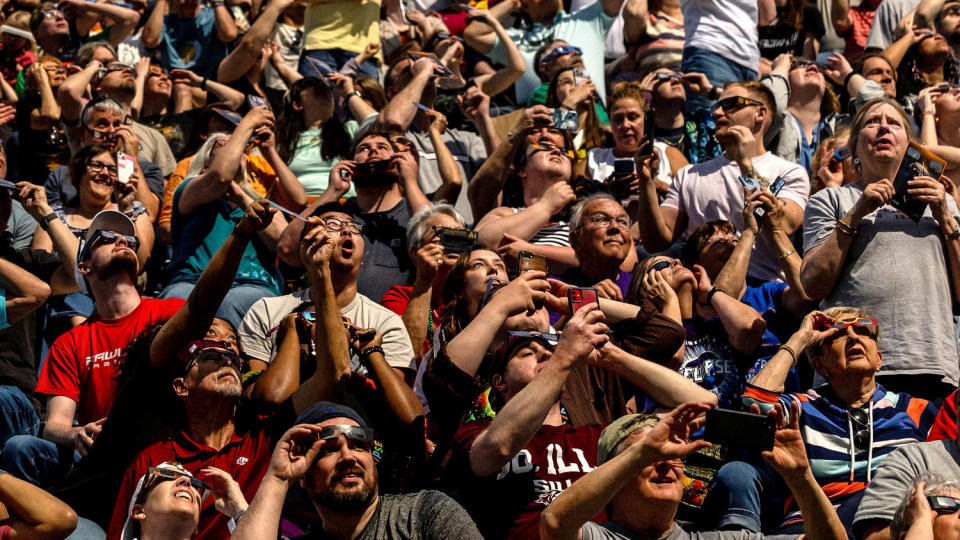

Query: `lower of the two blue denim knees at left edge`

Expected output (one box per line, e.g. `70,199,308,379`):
0,435,81,489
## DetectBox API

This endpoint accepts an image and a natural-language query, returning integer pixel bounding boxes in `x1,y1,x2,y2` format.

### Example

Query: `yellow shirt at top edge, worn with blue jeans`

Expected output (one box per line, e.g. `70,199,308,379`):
303,0,380,54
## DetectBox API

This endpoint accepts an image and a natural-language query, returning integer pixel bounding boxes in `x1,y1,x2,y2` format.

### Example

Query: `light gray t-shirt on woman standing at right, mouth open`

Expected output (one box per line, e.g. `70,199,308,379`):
803,184,960,386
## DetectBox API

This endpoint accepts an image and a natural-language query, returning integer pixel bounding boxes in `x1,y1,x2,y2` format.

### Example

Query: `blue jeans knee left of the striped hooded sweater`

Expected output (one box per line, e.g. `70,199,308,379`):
707,461,774,532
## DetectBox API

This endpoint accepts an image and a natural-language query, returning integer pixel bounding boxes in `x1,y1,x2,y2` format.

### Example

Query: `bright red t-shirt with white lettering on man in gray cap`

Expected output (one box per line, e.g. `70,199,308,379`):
37,298,184,425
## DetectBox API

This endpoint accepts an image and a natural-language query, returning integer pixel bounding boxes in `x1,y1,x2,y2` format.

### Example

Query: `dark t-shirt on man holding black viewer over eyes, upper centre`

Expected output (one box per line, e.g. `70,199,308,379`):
346,197,415,302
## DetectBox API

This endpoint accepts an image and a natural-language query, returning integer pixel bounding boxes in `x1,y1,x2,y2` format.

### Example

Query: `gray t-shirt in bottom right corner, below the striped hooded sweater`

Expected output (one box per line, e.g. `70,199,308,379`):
853,440,960,534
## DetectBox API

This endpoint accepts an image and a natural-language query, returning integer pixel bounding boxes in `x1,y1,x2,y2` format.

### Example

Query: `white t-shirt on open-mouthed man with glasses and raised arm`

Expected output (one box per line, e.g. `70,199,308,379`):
237,290,417,373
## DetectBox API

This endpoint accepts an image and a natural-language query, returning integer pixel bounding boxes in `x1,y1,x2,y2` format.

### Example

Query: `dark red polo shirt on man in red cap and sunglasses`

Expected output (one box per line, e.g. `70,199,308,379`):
107,408,296,540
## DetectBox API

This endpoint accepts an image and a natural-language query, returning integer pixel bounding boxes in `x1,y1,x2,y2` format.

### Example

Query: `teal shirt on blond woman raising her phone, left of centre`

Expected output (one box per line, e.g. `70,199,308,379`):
170,178,283,296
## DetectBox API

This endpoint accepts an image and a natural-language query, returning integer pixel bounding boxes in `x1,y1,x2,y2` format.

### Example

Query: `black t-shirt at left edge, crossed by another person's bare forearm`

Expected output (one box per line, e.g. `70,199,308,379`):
0,237,60,406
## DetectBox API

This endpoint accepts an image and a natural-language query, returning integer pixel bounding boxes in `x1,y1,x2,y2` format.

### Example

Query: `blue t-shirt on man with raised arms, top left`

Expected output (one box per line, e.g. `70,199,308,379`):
160,6,229,79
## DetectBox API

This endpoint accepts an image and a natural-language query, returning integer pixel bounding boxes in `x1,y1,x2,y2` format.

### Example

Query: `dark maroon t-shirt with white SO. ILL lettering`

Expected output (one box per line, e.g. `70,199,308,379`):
454,420,605,539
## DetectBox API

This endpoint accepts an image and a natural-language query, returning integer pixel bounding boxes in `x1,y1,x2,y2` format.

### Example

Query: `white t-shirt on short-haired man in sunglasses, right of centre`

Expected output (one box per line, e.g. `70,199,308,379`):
661,152,810,281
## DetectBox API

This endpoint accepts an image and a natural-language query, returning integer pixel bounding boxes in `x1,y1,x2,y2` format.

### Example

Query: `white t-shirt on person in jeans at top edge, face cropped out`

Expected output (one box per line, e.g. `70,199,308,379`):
682,0,760,71
